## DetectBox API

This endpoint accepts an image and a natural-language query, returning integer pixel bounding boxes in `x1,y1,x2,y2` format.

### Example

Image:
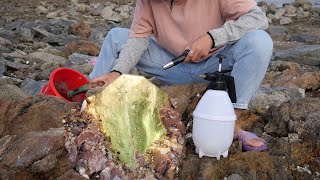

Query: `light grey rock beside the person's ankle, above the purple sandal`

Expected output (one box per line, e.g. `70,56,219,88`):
249,87,305,113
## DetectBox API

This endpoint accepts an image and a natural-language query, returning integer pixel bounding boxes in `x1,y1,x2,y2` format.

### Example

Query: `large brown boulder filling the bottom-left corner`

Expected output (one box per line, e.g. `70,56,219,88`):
0,129,72,179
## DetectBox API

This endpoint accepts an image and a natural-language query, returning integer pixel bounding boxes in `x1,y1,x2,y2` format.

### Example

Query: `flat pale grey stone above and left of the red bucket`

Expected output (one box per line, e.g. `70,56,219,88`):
26,52,66,65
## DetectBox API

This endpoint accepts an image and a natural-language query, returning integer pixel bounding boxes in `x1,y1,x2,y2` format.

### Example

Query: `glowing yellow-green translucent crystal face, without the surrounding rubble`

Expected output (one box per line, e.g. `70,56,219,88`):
88,75,169,167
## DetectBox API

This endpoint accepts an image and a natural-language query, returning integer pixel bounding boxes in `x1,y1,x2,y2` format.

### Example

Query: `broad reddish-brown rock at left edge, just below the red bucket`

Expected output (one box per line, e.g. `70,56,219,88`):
0,96,72,136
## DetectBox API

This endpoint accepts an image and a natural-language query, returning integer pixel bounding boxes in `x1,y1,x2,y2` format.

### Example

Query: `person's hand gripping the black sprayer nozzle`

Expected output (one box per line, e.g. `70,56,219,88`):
184,34,213,63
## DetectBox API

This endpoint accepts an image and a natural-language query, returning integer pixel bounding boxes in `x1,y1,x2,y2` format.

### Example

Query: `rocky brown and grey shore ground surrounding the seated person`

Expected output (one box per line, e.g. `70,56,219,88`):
0,0,320,179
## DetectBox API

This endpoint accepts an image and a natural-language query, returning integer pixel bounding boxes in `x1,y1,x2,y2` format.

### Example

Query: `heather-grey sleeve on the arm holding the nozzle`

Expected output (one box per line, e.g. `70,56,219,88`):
209,4,268,47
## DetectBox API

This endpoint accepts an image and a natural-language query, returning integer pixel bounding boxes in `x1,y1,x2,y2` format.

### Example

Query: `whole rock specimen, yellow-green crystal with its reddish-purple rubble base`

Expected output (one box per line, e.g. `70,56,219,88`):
64,75,186,179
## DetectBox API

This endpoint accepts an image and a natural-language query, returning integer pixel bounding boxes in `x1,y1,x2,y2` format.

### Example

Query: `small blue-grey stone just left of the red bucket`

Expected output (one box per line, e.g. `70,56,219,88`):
20,78,48,96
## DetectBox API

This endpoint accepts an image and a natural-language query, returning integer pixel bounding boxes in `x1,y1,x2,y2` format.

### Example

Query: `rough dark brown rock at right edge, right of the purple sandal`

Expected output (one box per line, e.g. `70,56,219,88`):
265,98,320,141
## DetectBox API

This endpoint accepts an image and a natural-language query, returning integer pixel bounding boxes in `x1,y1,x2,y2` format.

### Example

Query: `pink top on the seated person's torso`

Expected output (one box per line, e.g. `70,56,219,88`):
130,0,256,55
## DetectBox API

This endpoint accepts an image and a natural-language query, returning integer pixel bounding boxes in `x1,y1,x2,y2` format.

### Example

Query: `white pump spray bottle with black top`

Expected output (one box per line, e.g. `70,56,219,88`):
192,55,236,160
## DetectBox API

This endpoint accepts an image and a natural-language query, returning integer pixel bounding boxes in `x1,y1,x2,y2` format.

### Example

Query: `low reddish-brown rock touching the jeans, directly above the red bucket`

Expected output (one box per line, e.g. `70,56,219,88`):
67,41,100,56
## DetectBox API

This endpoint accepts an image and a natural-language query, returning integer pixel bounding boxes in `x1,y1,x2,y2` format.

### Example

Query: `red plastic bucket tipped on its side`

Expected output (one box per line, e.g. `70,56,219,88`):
40,68,89,102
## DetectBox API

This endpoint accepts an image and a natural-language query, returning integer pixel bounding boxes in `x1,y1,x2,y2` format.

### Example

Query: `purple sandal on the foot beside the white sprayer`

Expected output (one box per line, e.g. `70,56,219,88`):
237,131,267,151
